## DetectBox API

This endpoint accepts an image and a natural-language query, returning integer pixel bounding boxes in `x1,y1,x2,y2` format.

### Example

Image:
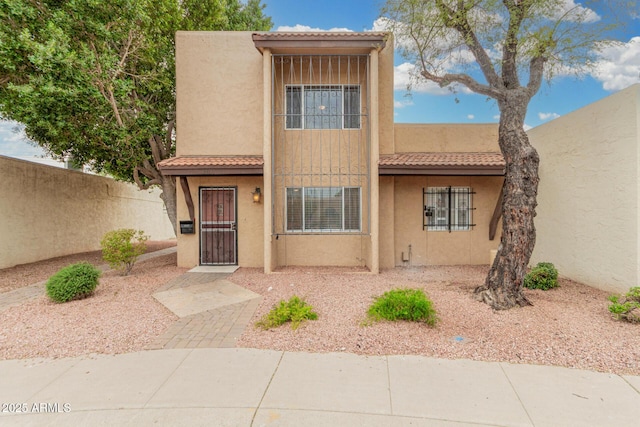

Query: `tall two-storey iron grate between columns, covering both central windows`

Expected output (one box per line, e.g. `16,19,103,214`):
271,54,370,235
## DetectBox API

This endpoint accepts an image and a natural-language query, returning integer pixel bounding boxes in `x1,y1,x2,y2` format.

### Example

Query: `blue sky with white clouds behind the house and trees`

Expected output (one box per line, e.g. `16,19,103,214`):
0,0,640,164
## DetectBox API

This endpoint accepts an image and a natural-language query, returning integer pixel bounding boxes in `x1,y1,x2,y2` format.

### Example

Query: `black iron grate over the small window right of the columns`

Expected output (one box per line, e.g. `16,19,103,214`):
422,187,475,232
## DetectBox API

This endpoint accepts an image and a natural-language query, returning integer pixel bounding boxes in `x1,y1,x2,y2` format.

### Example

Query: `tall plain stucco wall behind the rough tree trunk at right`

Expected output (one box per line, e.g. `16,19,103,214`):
528,85,640,292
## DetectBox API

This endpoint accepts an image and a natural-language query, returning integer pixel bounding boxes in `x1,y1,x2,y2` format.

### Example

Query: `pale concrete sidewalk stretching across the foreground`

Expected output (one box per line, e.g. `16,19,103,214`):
0,348,640,426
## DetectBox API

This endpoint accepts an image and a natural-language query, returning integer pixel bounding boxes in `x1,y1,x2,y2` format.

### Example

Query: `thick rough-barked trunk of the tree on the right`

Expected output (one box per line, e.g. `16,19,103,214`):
474,93,540,310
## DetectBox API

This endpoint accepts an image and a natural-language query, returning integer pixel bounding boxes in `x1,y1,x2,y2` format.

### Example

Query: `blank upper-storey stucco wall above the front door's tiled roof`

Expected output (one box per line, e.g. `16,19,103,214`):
176,31,263,156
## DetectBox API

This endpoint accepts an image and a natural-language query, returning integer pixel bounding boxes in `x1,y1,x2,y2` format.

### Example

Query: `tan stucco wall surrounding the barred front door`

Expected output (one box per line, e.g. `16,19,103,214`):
178,177,265,268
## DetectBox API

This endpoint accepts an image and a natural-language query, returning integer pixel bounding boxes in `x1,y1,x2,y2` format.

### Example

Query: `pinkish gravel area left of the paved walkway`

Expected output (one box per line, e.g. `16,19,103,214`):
0,243,186,359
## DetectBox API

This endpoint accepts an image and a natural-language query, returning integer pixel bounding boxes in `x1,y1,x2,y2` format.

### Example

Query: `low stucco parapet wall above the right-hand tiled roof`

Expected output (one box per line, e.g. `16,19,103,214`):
394,123,500,153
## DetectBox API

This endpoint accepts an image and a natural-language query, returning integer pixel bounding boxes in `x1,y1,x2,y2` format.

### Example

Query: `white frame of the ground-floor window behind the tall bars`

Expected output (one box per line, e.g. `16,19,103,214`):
284,186,362,234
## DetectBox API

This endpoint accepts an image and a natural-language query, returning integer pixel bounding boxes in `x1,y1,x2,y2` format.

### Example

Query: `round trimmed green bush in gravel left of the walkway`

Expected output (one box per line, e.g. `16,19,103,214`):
46,262,100,302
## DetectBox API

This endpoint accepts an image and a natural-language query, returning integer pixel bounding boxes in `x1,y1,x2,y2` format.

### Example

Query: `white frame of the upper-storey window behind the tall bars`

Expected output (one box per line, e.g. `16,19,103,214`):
284,84,362,130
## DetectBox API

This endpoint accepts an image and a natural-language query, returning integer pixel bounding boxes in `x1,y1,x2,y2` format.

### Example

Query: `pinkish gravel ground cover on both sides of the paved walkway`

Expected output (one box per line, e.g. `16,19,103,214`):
0,249,640,375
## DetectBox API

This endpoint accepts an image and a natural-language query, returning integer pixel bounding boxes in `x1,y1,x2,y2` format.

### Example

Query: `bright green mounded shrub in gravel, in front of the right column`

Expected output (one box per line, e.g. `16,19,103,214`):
367,289,438,326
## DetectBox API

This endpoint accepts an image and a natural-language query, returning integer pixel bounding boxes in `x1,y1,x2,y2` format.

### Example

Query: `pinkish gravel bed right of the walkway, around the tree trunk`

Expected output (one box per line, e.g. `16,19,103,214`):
231,266,640,375
